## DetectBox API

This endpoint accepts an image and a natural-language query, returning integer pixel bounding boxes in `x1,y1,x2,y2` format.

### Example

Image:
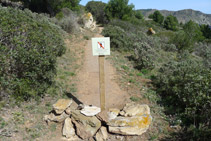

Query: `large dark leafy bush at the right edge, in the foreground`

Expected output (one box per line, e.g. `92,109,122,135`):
153,53,211,139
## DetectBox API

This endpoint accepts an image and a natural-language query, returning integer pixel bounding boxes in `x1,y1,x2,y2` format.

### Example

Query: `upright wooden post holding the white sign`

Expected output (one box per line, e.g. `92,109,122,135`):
99,55,105,111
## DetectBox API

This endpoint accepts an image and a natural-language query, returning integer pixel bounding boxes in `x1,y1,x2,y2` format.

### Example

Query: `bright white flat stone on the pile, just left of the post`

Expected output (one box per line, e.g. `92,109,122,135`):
81,106,101,116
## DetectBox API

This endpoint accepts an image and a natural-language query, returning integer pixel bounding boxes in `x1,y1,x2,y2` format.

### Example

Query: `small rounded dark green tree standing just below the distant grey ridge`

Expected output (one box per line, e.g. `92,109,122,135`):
164,15,178,31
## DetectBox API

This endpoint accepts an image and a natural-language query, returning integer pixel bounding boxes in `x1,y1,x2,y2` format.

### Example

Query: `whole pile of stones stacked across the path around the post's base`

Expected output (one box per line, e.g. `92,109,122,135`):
44,99,152,141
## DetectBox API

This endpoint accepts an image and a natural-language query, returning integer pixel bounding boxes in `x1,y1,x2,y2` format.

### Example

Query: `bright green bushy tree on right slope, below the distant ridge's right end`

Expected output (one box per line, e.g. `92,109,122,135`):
183,20,203,42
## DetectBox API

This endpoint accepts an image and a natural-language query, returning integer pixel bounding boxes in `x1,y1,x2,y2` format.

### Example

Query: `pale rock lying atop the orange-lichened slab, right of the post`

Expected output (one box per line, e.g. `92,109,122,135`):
122,103,150,117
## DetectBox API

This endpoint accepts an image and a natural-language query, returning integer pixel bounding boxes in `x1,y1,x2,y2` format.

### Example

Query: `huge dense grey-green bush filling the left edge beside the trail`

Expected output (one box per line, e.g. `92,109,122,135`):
0,6,65,100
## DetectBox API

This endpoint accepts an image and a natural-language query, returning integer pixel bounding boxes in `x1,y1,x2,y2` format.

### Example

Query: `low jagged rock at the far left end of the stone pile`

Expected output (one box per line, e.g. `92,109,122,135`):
44,112,69,122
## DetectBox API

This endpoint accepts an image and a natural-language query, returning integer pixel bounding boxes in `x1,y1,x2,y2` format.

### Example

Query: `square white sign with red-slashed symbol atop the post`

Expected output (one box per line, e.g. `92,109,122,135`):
92,37,110,56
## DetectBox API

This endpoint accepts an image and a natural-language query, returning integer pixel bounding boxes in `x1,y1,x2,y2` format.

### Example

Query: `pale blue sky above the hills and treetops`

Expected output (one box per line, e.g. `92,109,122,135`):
80,0,211,14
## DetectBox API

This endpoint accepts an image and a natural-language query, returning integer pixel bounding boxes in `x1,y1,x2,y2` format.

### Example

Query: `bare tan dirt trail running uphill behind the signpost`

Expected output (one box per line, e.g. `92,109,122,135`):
77,28,128,109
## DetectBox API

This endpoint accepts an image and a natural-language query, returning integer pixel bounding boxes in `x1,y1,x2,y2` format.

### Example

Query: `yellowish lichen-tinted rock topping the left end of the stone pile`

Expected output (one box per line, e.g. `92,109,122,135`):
53,99,72,114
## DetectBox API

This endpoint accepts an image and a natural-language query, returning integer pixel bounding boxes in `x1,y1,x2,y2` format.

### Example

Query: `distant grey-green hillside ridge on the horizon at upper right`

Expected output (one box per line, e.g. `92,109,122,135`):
140,9,211,25
